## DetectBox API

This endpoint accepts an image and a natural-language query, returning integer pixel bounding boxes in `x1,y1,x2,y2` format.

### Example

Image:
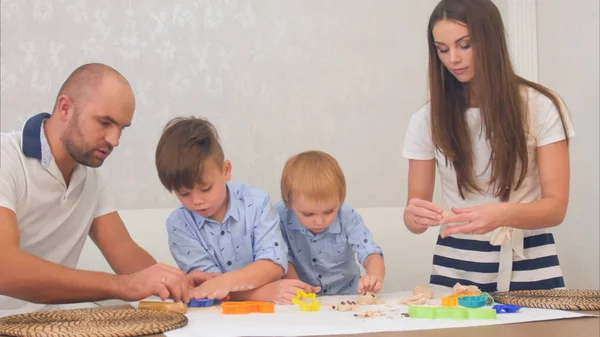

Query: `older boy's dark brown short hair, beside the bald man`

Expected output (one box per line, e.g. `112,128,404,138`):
156,117,225,192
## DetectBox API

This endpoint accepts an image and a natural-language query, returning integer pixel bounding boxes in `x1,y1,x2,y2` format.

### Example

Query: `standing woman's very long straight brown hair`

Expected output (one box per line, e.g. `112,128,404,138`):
427,0,568,201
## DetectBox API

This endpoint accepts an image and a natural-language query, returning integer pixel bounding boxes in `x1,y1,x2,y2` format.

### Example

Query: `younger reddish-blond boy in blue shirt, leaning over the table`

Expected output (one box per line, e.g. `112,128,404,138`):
275,151,385,295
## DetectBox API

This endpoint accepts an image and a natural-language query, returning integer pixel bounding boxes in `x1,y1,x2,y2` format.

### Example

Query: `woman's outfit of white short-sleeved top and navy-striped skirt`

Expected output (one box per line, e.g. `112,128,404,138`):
403,87,575,292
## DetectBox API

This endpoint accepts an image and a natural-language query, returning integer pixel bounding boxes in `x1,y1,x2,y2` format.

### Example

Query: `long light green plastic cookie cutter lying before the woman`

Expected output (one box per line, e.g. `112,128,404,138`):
408,306,497,320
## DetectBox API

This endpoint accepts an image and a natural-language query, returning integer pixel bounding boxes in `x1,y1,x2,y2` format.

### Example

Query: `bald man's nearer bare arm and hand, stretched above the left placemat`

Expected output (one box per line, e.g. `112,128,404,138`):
0,207,188,304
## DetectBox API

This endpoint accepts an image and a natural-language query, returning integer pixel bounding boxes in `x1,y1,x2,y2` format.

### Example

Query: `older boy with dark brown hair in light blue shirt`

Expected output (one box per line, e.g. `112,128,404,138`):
156,117,287,299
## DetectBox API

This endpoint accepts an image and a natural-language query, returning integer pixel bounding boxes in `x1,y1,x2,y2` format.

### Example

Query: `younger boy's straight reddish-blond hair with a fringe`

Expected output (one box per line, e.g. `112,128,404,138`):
281,151,346,208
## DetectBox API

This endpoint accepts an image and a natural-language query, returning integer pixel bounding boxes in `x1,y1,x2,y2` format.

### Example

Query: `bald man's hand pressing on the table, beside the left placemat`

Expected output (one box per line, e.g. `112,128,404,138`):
117,263,190,303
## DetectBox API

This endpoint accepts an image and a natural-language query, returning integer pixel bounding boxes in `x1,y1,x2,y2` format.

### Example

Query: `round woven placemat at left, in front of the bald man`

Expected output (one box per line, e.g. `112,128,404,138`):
0,309,188,337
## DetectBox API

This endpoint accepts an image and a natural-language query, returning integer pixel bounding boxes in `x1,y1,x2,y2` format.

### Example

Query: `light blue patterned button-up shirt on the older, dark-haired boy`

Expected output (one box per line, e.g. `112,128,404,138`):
167,183,287,273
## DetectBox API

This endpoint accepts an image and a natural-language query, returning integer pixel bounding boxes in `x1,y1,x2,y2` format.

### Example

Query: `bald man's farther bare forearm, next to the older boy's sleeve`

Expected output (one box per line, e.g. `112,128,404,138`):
89,212,156,274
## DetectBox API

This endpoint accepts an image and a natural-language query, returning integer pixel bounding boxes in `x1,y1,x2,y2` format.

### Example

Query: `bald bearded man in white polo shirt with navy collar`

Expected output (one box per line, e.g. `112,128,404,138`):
0,64,210,313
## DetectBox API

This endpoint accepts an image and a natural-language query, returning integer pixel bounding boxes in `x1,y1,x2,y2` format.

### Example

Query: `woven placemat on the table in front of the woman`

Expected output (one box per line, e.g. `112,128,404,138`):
490,289,600,311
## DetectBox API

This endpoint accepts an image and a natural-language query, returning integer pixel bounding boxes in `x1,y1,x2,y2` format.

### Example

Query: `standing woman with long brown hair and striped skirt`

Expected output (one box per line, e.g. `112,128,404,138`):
403,0,574,291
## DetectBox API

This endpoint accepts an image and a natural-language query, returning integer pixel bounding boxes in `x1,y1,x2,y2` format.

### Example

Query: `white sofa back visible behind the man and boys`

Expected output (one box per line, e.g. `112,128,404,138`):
78,207,437,292
